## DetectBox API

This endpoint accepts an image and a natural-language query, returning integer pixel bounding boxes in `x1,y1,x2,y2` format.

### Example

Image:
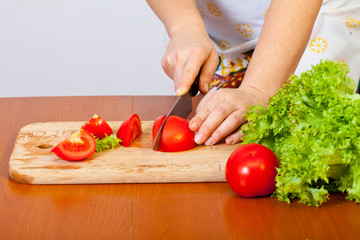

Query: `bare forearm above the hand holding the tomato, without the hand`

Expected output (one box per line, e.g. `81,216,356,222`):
242,0,322,101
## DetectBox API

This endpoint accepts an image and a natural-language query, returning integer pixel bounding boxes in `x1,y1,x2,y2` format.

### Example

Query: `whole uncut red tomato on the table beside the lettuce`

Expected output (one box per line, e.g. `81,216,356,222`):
225,143,279,197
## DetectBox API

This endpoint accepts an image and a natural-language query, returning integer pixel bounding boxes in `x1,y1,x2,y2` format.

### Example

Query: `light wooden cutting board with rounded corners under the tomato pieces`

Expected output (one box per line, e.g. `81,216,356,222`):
9,121,238,184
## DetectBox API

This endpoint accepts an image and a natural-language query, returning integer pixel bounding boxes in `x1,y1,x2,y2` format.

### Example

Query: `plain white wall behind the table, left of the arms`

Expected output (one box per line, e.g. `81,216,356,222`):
0,0,174,97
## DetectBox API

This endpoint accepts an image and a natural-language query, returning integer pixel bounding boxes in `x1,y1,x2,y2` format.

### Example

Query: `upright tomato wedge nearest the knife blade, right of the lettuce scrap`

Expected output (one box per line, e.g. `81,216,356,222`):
116,114,142,147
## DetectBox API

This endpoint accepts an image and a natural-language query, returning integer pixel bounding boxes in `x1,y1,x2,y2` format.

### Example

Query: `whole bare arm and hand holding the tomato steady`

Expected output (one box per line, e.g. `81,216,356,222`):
190,0,322,145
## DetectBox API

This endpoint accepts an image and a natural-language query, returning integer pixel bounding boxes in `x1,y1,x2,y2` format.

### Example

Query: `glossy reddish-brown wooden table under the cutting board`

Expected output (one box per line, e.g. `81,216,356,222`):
0,96,360,240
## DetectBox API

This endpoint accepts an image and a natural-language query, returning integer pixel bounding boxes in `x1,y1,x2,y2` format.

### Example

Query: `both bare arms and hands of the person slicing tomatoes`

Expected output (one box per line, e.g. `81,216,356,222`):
147,0,322,145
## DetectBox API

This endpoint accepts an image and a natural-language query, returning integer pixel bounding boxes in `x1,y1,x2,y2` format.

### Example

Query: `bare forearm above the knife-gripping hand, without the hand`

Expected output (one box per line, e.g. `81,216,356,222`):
147,0,206,38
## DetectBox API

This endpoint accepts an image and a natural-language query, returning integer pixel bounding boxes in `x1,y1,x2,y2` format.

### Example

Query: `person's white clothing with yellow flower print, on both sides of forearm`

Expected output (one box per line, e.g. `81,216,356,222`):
196,0,360,90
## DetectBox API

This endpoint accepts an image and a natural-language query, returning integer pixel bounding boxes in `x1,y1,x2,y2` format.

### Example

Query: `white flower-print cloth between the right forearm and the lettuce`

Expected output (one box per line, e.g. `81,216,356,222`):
295,0,360,85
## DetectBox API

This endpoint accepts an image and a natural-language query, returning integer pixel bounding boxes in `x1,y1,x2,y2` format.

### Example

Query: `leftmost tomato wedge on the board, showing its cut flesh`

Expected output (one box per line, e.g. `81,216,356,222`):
51,129,96,161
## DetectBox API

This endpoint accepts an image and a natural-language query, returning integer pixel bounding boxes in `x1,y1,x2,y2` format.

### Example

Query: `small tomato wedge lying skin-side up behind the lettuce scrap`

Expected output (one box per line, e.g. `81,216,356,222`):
82,114,113,139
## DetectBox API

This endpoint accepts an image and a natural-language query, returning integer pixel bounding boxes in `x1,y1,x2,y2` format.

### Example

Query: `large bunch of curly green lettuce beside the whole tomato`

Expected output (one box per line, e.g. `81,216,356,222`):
241,60,360,206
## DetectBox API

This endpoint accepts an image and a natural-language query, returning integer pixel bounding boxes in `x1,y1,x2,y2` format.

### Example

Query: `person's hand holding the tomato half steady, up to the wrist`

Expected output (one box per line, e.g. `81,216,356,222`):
189,86,268,145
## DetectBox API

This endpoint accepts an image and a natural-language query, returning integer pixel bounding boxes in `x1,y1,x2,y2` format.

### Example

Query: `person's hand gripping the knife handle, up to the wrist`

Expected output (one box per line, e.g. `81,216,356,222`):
161,26,219,96
